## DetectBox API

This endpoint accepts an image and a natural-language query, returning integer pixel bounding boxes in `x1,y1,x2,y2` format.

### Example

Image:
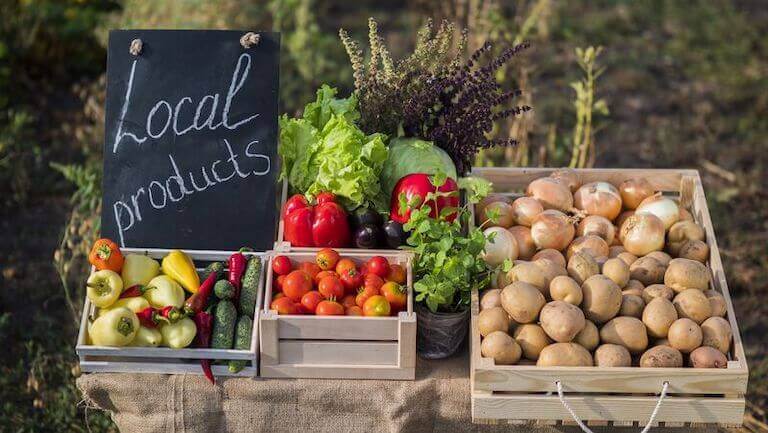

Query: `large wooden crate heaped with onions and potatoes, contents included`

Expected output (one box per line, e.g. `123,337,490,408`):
470,168,748,428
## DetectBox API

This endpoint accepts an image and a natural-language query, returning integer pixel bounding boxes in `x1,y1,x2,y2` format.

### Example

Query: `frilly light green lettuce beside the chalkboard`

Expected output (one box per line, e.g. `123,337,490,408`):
278,85,388,209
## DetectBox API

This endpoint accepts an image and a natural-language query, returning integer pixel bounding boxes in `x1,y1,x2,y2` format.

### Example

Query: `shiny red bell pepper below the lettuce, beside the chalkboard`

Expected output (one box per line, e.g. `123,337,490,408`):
283,192,351,248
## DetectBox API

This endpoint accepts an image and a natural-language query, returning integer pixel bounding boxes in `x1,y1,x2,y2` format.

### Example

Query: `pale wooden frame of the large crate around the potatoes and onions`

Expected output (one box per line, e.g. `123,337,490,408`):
470,168,748,426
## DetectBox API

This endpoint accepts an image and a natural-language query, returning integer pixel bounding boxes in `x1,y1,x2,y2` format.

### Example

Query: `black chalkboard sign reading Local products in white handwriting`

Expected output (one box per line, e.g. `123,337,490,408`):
101,30,280,250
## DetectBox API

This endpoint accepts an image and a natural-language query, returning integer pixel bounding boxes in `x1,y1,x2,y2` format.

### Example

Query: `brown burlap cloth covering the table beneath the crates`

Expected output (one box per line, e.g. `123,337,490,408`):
77,351,714,433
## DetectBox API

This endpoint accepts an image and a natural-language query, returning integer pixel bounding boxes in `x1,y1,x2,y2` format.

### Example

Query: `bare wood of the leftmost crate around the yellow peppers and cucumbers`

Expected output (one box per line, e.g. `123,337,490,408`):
75,248,267,377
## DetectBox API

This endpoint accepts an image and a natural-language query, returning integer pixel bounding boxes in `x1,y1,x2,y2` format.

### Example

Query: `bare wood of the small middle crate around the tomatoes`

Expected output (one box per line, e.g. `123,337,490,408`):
259,249,416,380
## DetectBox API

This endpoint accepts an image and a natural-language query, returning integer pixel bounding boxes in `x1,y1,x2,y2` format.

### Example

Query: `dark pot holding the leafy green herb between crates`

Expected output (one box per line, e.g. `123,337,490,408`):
416,304,469,359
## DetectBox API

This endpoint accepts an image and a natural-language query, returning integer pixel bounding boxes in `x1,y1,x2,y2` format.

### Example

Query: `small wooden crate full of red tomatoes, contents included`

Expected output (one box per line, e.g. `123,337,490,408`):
259,248,416,380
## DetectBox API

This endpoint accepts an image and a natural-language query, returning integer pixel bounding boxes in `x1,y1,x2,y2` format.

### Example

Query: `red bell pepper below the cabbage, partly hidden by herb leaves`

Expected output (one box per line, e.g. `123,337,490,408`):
389,173,459,224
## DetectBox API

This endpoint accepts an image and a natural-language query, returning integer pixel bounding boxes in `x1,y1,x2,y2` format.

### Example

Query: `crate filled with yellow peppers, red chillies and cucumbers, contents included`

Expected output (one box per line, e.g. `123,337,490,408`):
76,239,265,383
